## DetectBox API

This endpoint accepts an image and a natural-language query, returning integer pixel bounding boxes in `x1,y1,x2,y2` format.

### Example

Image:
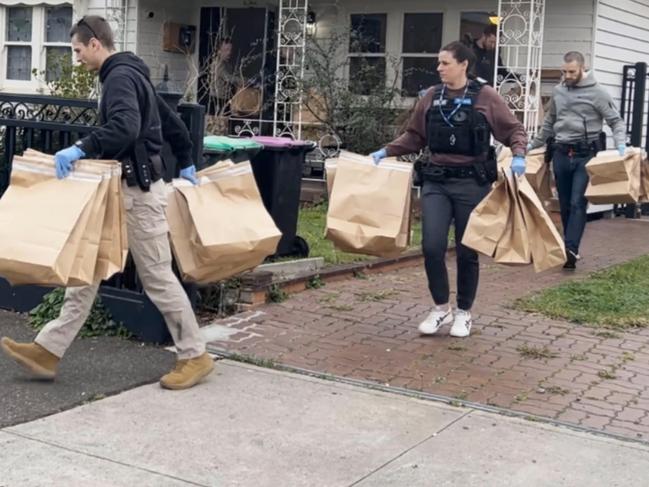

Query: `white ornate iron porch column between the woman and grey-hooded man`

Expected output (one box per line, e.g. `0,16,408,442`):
494,0,545,137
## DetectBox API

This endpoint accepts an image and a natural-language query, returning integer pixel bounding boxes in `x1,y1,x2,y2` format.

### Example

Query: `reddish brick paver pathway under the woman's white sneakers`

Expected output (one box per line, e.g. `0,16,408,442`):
204,219,649,441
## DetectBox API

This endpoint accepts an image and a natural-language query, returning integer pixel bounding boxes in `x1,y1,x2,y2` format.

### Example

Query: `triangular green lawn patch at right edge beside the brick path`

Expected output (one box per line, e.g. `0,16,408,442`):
515,256,649,329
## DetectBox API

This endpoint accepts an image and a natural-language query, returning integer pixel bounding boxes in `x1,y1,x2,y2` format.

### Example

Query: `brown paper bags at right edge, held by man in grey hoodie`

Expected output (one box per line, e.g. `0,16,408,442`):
586,147,644,204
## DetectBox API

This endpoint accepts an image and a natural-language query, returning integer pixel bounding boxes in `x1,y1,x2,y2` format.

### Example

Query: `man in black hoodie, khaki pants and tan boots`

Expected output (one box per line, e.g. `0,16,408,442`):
0,16,214,389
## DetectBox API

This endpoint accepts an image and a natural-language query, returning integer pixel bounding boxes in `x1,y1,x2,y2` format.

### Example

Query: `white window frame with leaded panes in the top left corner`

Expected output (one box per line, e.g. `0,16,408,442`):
0,1,74,93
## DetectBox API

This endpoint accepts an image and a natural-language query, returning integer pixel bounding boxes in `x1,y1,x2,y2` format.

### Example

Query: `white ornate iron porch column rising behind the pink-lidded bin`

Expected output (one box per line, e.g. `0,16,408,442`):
273,0,309,139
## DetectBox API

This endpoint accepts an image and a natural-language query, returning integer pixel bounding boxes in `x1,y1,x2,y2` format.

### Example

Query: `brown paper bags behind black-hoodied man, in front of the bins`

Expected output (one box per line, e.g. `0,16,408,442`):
167,161,282,283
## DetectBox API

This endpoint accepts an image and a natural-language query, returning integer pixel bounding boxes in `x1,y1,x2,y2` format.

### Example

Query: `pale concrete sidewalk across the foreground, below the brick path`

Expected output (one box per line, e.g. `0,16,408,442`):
0,360,649,487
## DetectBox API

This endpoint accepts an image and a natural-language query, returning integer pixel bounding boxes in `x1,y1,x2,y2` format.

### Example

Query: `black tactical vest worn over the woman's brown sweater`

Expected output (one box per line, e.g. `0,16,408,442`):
426,80,491,158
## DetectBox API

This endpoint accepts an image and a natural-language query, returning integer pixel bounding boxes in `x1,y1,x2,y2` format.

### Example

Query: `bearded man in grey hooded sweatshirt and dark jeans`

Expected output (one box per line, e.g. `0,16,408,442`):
528,51,626,270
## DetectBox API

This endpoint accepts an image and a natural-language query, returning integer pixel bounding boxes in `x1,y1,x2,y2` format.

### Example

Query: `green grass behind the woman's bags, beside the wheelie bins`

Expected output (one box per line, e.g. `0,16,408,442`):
297,204,421,264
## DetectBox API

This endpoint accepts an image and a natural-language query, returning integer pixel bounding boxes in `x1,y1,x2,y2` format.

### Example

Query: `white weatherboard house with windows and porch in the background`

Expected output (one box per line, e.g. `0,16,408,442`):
0,0,649,141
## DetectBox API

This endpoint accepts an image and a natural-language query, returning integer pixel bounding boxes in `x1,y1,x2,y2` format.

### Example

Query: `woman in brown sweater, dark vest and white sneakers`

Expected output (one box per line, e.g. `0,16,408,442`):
371,42,527,337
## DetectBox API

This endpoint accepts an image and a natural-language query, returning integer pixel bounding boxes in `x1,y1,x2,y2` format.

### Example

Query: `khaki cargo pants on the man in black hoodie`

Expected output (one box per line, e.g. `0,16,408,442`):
35,180,205,359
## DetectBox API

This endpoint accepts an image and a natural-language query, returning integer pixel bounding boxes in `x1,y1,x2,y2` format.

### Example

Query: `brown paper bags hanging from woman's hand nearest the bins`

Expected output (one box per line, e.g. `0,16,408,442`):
325,151,413,257
